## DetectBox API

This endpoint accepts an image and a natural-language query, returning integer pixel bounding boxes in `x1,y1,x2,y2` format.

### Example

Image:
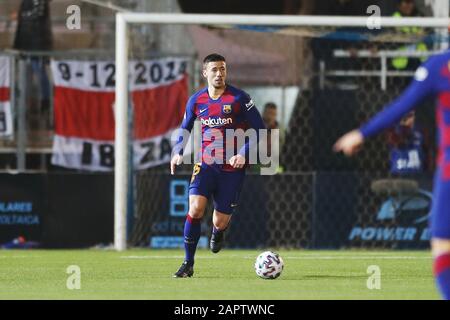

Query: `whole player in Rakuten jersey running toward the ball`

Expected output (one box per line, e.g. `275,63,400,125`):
170,54,264,278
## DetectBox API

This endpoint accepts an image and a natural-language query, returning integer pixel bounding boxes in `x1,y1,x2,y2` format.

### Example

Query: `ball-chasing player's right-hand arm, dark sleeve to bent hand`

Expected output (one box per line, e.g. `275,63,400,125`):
230,96,266,168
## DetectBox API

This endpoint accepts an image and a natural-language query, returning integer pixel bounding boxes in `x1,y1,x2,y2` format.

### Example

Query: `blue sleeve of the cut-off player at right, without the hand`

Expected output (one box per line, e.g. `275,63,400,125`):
360,56,440,138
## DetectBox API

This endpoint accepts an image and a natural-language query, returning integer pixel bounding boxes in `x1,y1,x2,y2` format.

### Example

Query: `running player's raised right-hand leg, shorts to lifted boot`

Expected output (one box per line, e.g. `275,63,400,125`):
209,170,245,253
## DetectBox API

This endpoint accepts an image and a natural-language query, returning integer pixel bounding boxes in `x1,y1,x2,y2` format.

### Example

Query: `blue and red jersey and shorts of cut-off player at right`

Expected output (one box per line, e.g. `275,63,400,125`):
360,51,450,239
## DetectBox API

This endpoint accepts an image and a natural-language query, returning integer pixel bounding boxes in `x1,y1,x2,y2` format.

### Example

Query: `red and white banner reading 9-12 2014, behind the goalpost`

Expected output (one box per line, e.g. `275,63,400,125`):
51,58,188,171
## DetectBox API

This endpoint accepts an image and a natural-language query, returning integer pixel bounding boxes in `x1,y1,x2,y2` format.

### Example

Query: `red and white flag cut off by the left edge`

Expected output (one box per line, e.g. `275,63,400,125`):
0,56,13,136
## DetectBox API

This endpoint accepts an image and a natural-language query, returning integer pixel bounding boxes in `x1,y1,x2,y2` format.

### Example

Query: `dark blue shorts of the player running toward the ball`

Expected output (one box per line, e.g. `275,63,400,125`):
189,163,245,214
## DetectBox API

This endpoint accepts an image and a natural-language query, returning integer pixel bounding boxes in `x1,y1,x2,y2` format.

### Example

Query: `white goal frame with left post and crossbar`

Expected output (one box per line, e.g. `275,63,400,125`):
114,12,449,251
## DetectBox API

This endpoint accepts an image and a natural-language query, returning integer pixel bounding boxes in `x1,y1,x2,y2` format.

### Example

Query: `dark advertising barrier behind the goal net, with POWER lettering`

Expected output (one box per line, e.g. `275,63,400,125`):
129,172,432,249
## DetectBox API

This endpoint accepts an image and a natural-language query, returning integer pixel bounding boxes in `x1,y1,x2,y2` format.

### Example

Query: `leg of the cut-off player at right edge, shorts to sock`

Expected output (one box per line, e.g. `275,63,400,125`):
431,173,450,300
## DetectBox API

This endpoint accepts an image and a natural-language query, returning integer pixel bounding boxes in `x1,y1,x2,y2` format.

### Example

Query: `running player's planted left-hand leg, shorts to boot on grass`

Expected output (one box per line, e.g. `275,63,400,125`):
174,164,212,278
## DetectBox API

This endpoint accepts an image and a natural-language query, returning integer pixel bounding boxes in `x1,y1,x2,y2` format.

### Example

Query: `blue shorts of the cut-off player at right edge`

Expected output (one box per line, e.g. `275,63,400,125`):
430,168,450,240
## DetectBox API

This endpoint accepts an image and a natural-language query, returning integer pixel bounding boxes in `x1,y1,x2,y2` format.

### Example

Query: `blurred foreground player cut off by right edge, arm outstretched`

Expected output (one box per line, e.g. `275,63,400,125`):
334,51,450,300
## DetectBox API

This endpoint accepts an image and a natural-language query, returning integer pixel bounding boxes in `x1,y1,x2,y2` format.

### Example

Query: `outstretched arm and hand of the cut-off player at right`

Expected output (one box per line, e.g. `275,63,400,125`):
333,58,434,155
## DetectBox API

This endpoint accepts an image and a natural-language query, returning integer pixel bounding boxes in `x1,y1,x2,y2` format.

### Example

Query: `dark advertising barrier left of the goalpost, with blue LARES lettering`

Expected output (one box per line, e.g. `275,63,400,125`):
0,173,114,248
